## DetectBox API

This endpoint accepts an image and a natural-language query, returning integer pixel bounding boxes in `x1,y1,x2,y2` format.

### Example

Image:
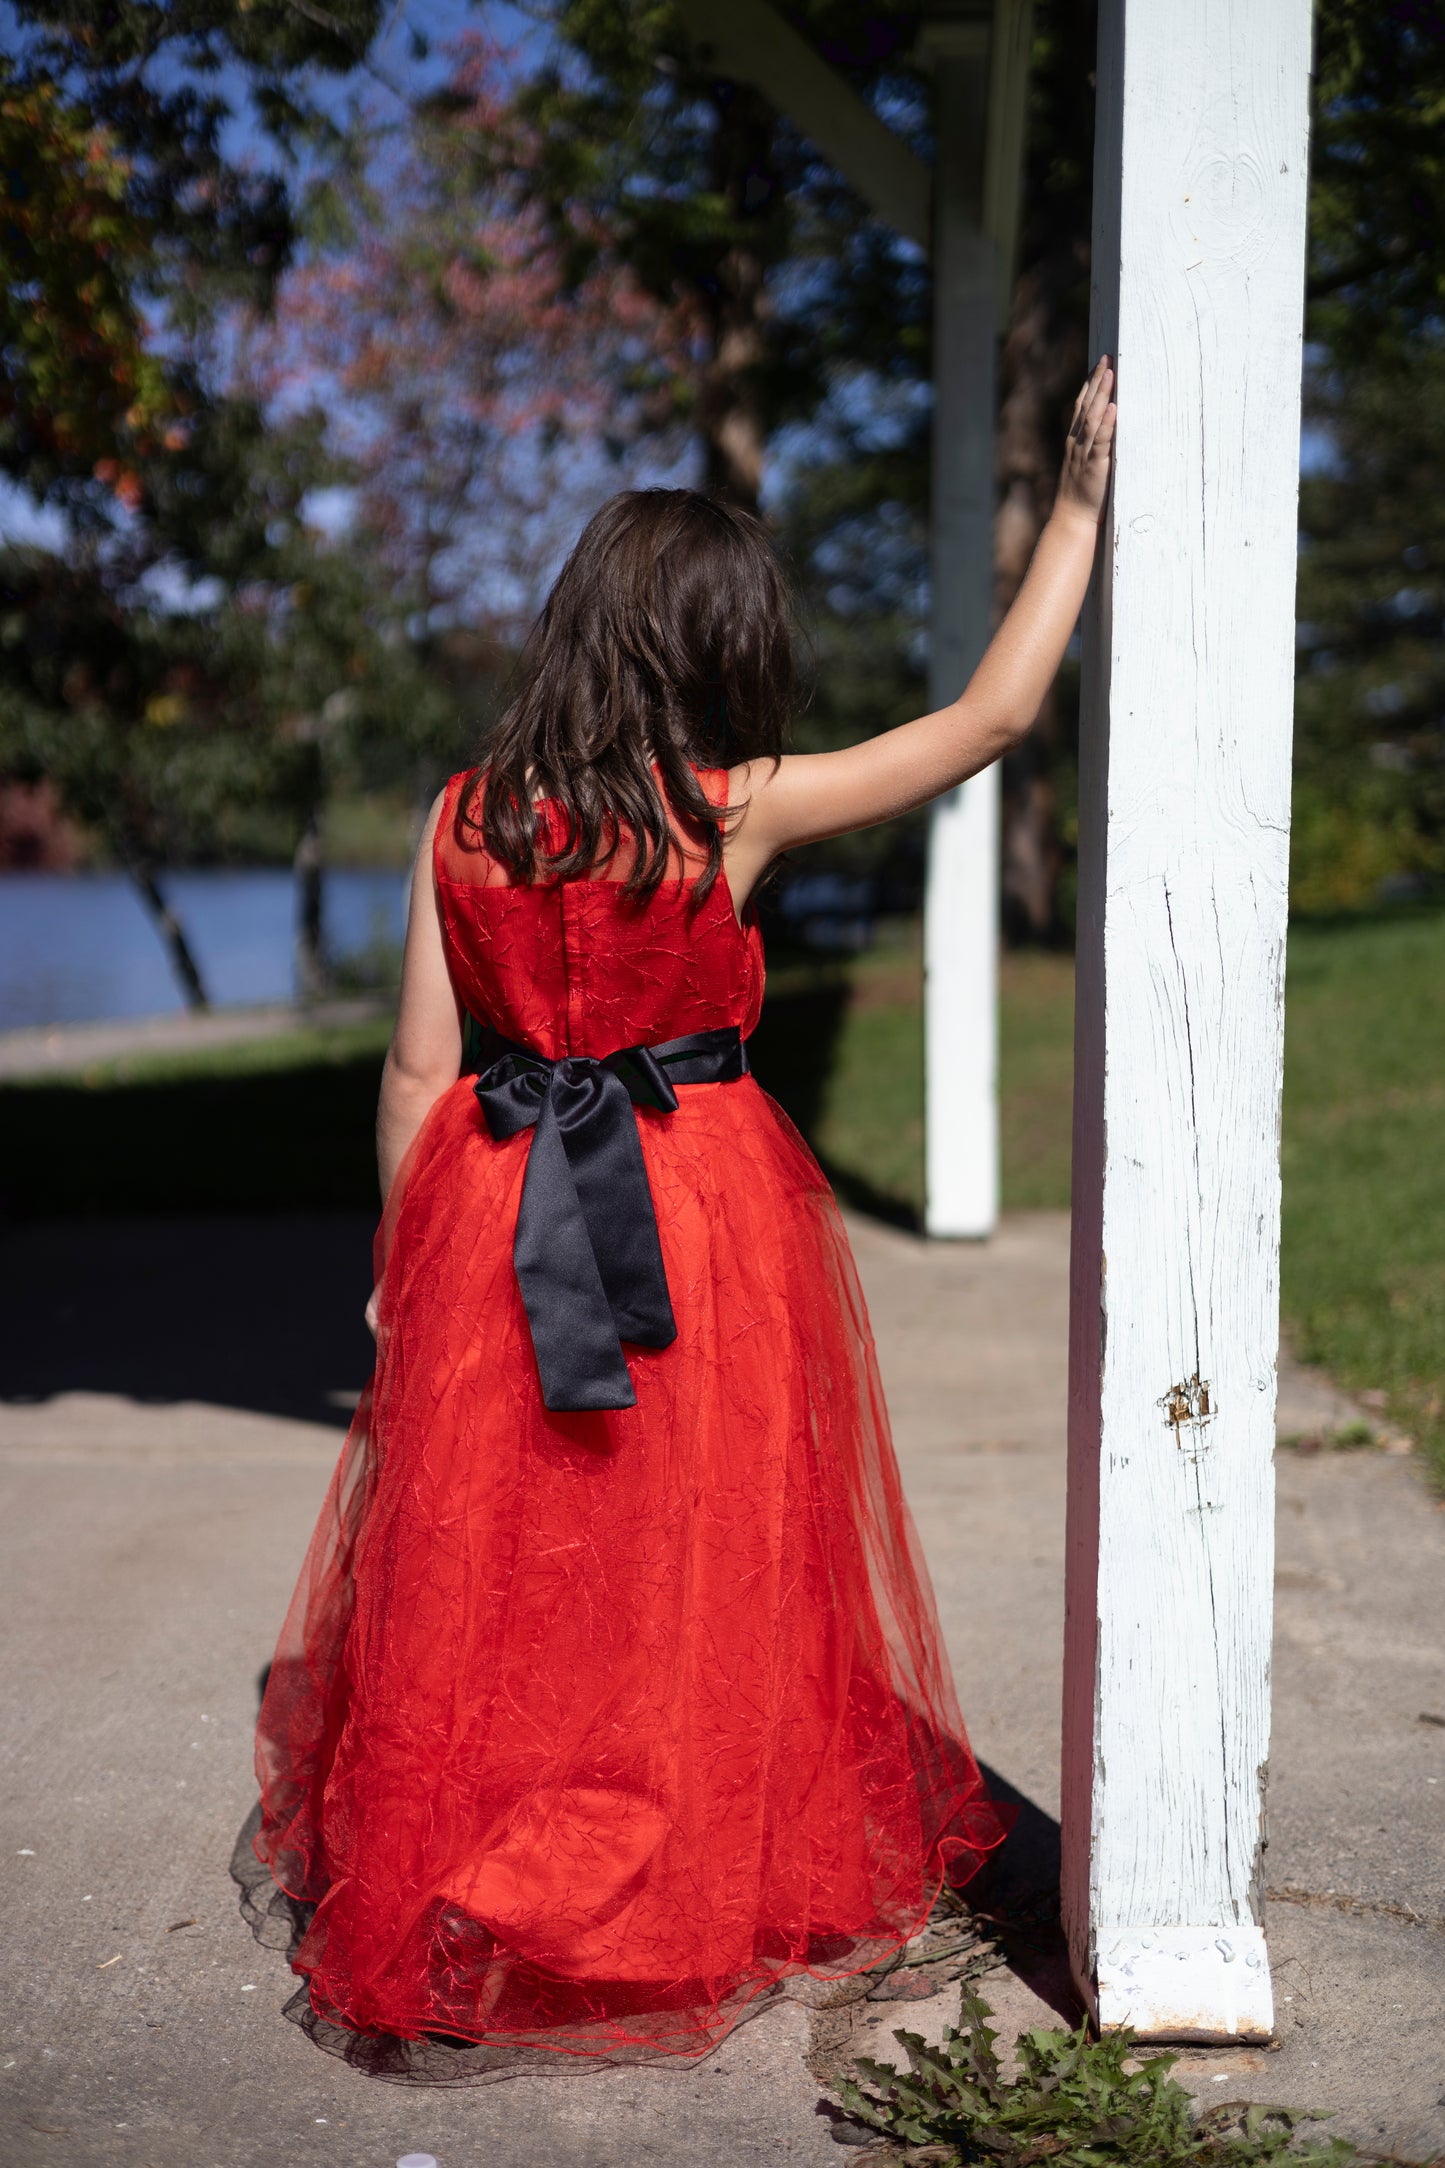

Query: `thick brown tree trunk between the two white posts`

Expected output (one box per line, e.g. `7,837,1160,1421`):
994,251,1083,941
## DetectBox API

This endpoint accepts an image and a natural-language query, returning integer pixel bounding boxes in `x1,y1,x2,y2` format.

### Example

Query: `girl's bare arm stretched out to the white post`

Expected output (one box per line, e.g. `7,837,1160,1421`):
726,353,1116,904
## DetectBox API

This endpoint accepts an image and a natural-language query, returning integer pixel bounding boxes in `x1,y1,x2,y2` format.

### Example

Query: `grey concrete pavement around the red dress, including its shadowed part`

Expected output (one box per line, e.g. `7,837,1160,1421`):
0,1214,1445,2168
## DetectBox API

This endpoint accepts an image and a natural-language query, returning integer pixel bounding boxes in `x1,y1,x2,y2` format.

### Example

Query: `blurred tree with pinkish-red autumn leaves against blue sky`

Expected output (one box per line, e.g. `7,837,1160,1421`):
253,37,687,813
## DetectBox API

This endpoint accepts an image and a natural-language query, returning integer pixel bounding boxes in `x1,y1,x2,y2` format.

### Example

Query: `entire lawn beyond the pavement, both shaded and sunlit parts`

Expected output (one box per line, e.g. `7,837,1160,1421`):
0,908,1445,1483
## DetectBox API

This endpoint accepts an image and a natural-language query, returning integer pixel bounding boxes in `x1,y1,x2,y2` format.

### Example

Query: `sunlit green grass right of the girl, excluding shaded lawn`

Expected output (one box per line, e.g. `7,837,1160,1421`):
769,908,1445,1487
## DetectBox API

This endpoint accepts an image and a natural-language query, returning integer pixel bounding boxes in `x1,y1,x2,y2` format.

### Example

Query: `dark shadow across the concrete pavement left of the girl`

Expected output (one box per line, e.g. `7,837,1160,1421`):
0,1212,375,1429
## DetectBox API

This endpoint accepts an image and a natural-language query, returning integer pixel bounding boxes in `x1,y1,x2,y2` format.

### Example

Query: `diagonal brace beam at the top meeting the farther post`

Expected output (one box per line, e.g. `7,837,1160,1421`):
678,0,929,249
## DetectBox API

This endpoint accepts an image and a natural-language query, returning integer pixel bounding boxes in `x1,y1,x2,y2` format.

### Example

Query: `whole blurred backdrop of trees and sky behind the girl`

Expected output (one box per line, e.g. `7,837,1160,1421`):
0,0,1445,997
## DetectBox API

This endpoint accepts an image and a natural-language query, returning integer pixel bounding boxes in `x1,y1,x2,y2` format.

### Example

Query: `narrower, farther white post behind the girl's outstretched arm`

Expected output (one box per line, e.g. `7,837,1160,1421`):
923,24,999,1236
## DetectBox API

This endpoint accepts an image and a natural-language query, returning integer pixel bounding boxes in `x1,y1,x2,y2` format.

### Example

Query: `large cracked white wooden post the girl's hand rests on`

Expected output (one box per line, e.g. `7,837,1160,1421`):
1064,0,1311,2040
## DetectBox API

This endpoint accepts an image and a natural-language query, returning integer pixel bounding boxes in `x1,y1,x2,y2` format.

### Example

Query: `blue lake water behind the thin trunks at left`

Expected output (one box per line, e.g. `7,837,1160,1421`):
0,867,407,1030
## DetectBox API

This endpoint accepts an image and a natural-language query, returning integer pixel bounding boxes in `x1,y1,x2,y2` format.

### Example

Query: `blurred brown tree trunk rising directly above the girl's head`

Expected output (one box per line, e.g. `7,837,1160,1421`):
698,82,778,512
